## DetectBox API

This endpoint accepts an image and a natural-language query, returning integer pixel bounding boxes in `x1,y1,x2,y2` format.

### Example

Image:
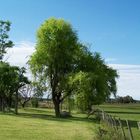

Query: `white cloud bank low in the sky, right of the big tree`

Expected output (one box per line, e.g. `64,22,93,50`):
109,64,140,99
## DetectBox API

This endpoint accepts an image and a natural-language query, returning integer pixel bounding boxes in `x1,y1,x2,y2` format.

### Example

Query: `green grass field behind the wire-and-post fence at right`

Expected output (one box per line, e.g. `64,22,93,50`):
99,104,140,140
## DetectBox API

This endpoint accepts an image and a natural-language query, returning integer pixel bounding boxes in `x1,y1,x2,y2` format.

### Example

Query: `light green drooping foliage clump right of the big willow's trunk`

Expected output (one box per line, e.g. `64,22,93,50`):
67,71,97,111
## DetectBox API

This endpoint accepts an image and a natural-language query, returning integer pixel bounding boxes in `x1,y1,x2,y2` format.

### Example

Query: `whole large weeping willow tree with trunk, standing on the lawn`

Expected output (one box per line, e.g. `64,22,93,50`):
29,18,117,117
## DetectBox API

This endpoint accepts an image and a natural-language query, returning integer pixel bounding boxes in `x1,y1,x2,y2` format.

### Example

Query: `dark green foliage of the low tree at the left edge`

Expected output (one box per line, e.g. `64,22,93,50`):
0,62,29,111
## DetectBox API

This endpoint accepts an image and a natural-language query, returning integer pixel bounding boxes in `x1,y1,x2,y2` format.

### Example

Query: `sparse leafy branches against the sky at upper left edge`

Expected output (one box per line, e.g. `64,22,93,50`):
0,20,13,60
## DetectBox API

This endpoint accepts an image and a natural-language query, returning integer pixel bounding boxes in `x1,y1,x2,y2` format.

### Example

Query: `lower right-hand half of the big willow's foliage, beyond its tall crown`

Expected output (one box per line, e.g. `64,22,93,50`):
66,47,118,111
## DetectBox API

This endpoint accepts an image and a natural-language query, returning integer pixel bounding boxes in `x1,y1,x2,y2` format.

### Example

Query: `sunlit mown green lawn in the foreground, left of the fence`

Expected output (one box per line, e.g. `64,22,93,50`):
0,108,99,140
